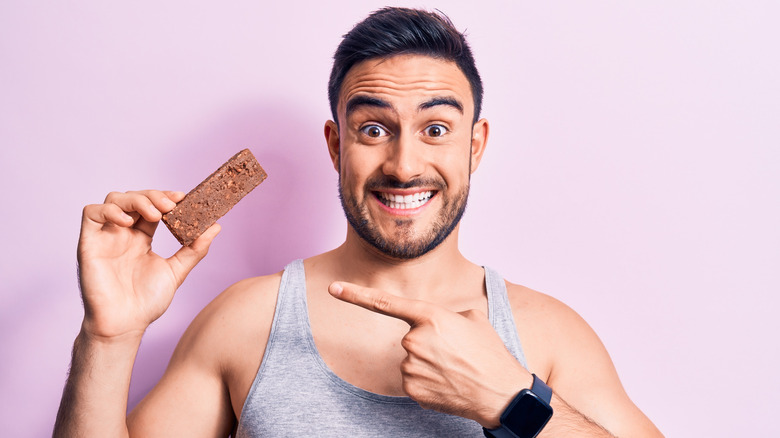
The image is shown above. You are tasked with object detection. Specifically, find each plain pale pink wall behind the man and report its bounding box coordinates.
[0,0,780,437]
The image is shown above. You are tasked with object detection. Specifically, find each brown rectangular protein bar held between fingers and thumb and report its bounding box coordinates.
[162,149,268,246]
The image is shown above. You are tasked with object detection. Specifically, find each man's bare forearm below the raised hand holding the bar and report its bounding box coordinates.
[53,330,141,437]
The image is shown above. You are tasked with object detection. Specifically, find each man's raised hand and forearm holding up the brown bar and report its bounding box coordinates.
[54,190,219,437]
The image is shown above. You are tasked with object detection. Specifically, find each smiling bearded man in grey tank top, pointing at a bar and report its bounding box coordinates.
[55,8,660,437]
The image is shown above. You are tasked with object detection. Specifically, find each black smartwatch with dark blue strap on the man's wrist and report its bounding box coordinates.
[482,374,552,438]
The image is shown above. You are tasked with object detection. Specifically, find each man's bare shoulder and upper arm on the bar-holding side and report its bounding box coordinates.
[127,273,281,438]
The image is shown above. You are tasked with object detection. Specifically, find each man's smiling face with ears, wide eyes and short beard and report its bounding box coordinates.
[326,55,487,259]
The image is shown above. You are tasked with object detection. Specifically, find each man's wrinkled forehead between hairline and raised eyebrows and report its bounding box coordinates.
[338,55,474,117]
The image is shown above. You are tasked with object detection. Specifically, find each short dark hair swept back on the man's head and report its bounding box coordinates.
[328,7,482,123]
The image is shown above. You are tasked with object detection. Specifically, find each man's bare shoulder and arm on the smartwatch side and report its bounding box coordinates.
[507,283,662,437]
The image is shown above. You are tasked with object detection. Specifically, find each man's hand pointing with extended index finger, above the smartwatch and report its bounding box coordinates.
[328,281,532,427]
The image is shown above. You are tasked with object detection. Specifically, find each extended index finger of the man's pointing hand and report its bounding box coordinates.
[328,281,440,327]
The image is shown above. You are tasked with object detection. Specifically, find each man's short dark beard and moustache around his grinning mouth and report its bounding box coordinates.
[339,176,469,260]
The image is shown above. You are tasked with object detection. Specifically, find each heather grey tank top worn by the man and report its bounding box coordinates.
[237,260,527,438]
